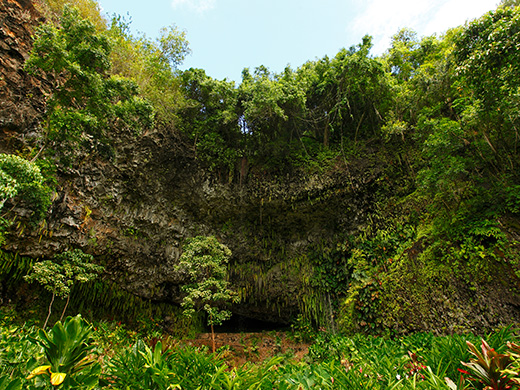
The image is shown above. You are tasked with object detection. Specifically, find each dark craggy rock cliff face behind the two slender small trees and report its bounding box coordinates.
[1,116,370,322]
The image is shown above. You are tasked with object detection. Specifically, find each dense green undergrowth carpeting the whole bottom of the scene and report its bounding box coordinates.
[0,308,520,390]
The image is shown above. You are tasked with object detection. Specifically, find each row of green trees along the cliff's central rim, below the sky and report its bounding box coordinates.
[175,36,389,175]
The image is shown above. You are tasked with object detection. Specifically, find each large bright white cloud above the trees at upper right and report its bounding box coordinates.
[348,0,499,54]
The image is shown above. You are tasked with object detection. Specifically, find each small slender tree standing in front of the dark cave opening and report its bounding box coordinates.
[177,236,238,352]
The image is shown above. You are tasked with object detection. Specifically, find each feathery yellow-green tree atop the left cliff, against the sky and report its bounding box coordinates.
[38,0,190,126]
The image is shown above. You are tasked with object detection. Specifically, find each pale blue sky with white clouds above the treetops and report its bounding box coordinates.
[98,0,499,82]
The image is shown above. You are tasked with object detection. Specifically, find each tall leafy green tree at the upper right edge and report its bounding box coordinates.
[454,7,520,180]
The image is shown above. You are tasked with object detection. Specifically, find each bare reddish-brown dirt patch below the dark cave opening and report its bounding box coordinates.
[182,331,309,366]
